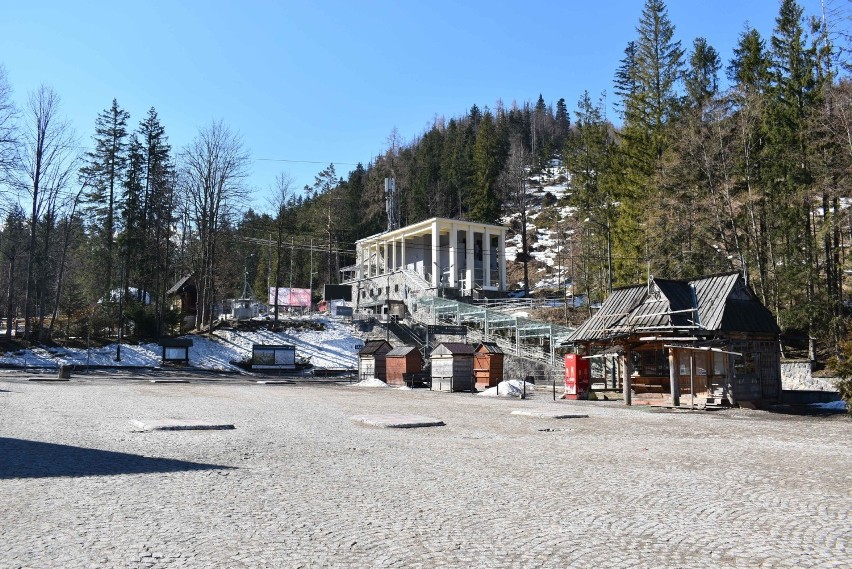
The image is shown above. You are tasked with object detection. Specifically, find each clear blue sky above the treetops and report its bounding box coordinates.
[0,0,820,210]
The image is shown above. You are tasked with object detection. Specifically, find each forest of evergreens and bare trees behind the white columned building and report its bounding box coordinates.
[0,0,852,358]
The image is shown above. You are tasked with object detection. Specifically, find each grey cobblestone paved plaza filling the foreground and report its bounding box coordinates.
[0,375,852,568]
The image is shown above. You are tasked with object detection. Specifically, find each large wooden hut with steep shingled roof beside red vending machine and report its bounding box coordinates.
[566,273,781,407]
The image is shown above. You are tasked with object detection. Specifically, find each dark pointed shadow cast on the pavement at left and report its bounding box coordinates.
[0,437,231,480]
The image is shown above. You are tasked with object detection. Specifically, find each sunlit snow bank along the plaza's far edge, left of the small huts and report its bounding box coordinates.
[0,317,363,371]
